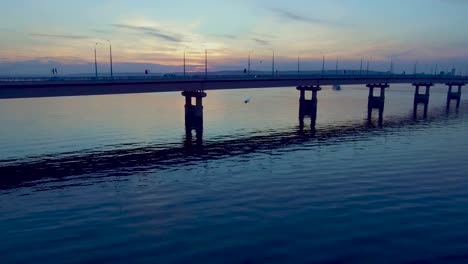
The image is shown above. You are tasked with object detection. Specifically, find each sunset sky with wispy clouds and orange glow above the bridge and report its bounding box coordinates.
[0,0,468,74]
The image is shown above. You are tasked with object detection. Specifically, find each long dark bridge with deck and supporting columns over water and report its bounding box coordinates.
[0,73,468,129]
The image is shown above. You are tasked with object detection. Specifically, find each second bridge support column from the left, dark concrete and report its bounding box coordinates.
[297,85,322,129]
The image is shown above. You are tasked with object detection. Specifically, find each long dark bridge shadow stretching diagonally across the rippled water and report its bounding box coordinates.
[0,104,468,190]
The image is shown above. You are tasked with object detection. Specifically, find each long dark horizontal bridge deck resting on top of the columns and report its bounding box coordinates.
[0,74,468,99]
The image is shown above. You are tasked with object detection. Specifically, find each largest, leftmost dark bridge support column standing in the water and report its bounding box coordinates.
[182,91,206,144]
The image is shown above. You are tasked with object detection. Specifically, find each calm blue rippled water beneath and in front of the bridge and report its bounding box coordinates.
[0,85,468,263]
